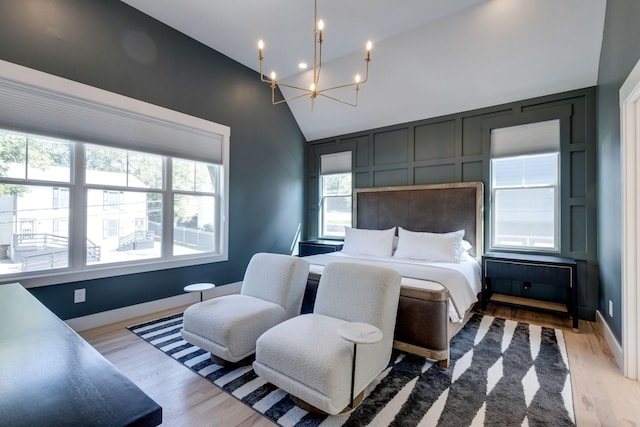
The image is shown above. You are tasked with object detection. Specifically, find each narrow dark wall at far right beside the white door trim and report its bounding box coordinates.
[597,0,640,342]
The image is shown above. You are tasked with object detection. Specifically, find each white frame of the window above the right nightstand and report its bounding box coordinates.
[489,119,561,253]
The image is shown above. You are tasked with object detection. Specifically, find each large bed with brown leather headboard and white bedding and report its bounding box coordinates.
[304,182,484,366]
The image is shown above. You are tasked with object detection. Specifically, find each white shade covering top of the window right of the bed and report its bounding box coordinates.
[491,119,560,159]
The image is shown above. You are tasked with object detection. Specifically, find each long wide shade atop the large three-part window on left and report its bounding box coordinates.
[0,61,230,164]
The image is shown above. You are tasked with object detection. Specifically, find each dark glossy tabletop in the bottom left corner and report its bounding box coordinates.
[0,283,162,426]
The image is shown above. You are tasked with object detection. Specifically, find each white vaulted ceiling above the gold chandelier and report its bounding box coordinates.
[123,0,606,141]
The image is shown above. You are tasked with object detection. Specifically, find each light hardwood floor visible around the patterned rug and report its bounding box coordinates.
[80,306,640,427]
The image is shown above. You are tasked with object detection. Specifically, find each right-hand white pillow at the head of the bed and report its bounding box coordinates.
[393,227,464,263]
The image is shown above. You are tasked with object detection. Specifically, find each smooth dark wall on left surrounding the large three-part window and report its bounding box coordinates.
[0,0,305,319]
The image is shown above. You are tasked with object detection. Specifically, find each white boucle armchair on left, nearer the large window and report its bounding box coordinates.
[181,253,309,362]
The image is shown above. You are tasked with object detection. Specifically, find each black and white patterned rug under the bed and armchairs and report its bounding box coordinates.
[129,314,575,427]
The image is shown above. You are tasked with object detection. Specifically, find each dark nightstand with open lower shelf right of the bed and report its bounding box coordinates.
[482,252,578,331]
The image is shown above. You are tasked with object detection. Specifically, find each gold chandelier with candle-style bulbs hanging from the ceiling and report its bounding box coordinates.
[258,0,372,108]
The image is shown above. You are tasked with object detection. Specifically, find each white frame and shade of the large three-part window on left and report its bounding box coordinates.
[0,60,231,288]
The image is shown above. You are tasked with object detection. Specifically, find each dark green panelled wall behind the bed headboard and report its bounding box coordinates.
[306,88,598,320]
